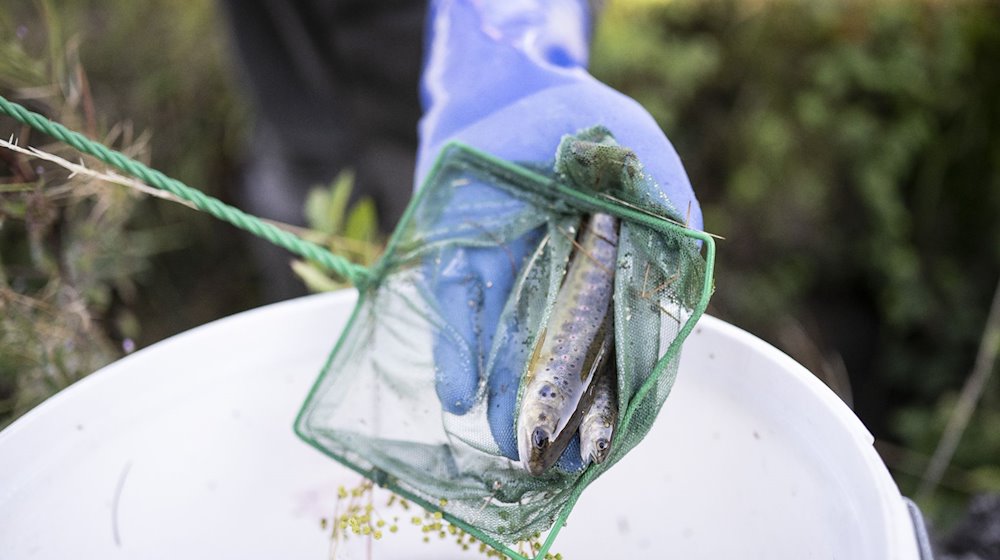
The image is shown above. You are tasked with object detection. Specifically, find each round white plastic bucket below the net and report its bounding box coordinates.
[0,291,919,560]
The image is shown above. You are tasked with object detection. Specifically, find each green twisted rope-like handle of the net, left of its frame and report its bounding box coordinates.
[0,95,372,288]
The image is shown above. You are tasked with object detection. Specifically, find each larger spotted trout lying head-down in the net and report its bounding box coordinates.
[517,214,618,476]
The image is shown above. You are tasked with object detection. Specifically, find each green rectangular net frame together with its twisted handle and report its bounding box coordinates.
[0,96,715,560]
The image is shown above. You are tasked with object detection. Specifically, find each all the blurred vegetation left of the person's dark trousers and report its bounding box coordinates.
[0,0,254,420]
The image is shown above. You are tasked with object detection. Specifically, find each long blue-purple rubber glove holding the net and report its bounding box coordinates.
[416,0,702,470]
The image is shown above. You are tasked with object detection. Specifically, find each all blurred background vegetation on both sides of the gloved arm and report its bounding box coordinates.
[0,0,1000,527]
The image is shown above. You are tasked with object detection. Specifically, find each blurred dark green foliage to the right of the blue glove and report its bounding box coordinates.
[592,0,1000,518]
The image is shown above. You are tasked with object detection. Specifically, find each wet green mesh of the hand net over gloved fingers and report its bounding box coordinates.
[296,127,711,544]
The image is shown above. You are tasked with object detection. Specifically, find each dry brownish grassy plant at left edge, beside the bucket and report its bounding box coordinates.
[0,0,154,420]
